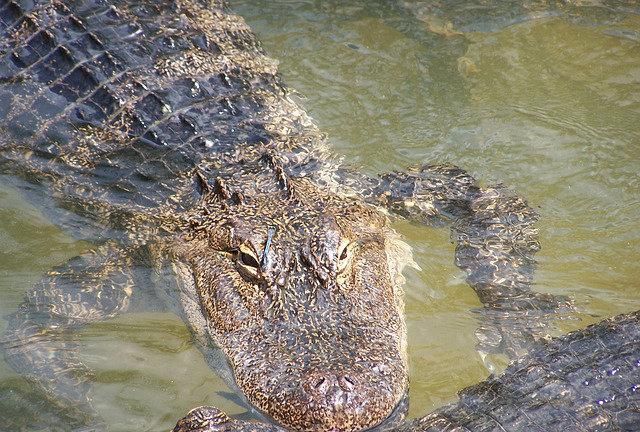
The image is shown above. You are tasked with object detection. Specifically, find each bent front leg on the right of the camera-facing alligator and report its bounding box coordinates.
[354,165,569,358]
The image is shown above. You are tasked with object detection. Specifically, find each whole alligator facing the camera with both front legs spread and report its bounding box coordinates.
[0,0,632,431]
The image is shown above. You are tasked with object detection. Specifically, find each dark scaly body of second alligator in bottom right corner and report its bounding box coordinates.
[408,311,640,432]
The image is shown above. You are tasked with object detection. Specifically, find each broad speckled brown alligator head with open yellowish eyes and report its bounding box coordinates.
[178,164,411,431]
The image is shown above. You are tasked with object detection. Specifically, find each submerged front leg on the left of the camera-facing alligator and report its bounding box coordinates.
[0,241,132,427]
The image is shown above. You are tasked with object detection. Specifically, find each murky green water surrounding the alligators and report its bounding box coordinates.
[0,0,640,431]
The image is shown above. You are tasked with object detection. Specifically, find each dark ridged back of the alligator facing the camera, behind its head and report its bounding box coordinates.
[0,0,317,221]
